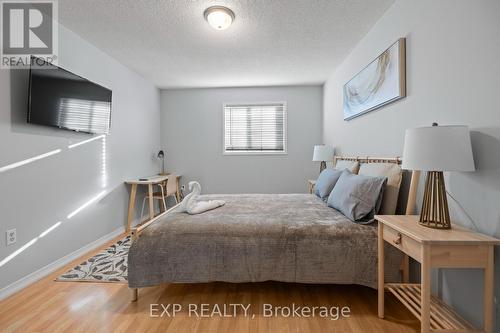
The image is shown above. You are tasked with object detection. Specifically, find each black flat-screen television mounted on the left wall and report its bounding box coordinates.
[28,57,112,134]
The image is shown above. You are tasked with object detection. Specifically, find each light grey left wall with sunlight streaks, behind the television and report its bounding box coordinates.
[0,26,160,289]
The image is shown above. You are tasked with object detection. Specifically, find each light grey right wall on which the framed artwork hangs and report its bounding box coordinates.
[323,0,500,326]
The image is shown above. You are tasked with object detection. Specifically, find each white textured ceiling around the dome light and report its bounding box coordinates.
[59,0,394,88]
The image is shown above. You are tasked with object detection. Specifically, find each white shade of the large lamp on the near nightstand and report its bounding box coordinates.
[402,126,475,171]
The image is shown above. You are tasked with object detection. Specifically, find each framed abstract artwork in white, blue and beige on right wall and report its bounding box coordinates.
[343,38,406,120]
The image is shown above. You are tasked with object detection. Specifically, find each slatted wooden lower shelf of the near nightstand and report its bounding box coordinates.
[385,283,476,332]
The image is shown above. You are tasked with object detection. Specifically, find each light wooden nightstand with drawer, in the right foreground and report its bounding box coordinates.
[375,215,500,333]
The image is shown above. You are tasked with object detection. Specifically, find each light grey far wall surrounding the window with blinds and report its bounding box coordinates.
[161,86,322,193]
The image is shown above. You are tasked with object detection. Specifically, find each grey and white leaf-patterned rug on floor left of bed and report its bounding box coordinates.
[56,236,132,283]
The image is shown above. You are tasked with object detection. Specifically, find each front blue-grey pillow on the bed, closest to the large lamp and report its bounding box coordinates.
[328,170,387,223]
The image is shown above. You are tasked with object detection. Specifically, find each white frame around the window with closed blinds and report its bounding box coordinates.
[222,101,288,156]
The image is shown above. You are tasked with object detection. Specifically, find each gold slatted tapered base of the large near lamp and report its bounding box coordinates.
[419,171,451,229]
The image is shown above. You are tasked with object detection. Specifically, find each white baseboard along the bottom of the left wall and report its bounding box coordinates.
[0,227,125,301]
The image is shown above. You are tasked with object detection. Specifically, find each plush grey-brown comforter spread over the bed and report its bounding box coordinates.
[128,194,401,288]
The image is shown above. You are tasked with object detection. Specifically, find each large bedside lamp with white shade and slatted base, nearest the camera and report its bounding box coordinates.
[402,123,475,229]
